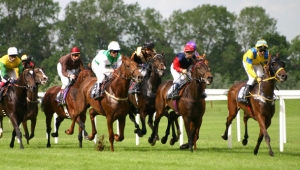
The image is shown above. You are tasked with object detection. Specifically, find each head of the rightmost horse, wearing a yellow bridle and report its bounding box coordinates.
[265,56,287,82]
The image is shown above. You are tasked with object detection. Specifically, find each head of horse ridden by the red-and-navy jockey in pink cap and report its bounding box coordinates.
[189,60,213,85]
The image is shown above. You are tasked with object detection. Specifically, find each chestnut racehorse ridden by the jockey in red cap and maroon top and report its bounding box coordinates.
[41,69,93,147]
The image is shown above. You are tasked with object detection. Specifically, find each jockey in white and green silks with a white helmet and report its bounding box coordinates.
[92,41,122,100]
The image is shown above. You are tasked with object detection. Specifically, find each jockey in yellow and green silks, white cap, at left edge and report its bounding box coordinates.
[0,47,23,88]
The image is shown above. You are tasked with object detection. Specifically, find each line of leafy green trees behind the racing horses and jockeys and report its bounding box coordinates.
[0,0,300,91]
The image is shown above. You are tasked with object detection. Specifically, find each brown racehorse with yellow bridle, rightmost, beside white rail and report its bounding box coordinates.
[222,56,287,156]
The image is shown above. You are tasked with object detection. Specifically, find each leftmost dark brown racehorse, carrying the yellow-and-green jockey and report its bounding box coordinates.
[0,68,37,149]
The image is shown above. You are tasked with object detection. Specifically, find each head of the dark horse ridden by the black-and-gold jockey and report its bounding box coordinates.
[149,54,166,77]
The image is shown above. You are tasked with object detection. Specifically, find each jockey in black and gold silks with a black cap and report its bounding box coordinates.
[128,41,156,93]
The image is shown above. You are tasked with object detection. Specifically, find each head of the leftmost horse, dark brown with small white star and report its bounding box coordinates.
[18,68,37,92]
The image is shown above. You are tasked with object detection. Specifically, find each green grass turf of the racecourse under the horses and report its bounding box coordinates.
[0,100,300,170]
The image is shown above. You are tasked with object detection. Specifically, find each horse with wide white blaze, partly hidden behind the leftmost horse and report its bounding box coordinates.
[22,67,48,144]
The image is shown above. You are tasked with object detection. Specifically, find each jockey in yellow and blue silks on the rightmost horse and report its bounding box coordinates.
[239,39,269,103]
